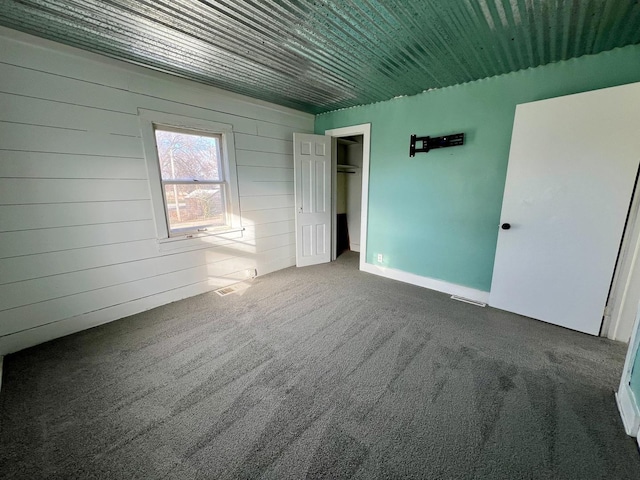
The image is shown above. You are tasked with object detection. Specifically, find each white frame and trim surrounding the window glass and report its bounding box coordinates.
[138,109,243,250]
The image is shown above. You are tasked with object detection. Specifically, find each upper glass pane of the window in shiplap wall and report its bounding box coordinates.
[156,129,222,180]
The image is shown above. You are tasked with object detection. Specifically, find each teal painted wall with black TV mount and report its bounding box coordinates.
[315,45,640,291]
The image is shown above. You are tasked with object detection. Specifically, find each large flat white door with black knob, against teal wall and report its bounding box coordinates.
[489,84,640,335]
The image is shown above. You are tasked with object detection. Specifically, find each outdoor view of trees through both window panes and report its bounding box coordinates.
[155,127,226,233]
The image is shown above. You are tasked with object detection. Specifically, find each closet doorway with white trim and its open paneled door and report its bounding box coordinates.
[293,123,371,270]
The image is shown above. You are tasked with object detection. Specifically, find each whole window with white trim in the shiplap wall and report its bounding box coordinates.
[140,111,241,246]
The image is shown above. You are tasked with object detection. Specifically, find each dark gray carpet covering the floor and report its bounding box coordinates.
[0,254,640,479]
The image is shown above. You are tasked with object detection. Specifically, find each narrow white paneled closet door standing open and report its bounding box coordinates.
[293,133,332,267]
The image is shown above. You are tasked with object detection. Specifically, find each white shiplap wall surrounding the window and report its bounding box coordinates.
[0,28,313,355]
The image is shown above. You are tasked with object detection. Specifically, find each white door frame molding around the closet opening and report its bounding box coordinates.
[324,123,371,270]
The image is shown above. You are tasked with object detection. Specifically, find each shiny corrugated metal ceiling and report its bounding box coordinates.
[0,0,640,113]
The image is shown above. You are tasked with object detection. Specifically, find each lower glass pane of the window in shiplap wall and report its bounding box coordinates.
[164,184,226,231]
